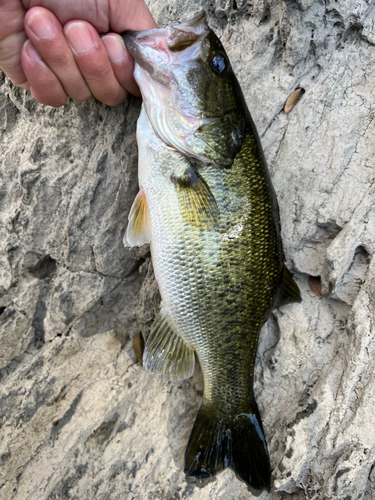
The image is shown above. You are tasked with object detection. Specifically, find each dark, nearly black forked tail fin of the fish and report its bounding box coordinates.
[185,403,271,491]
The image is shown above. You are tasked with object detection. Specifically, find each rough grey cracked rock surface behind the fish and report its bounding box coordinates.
[0,0,375,500]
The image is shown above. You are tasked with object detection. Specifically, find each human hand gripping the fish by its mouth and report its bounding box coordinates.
[0,0,157,107]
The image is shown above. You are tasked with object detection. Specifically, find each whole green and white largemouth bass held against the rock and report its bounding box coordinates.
[123,11,301,491]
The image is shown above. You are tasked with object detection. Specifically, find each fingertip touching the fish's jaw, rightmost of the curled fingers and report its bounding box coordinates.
[102,33,141,97]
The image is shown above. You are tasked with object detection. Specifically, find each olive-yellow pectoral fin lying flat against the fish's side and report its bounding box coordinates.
[171,166,220,229]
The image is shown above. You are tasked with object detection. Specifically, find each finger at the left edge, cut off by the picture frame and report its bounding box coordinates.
[0,0,28,88]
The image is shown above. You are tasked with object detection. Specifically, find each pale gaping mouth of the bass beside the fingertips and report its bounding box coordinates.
[121,10,209,76]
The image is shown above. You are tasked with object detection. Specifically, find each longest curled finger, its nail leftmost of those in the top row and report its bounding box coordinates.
[25,7,91,101]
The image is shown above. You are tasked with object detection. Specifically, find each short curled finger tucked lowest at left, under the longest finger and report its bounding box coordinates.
[21,40,68,108]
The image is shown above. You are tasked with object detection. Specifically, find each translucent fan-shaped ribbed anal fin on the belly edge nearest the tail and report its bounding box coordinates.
[143,303,195,380]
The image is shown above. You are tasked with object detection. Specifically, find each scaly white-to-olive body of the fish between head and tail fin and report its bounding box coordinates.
[142,118,282,413]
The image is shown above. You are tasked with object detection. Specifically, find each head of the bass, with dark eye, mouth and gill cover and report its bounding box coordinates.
[123,12,247,166]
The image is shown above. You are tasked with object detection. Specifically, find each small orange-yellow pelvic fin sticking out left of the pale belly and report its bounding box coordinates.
[124,189,151,247]
